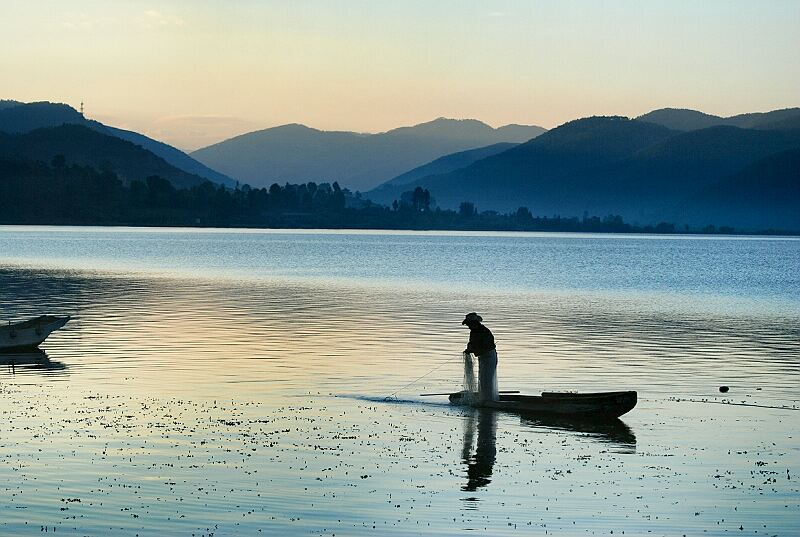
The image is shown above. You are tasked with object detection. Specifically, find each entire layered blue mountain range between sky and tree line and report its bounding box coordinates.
[0,101,800,231]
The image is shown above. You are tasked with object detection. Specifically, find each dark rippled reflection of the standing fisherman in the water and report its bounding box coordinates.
[461,409,497,491]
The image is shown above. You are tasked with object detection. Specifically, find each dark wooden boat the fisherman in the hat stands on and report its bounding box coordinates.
[450,391,637,419]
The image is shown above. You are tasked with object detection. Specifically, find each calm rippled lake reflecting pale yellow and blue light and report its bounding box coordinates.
[0,226,800,536]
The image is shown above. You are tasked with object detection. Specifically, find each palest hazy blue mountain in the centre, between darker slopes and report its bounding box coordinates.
[192,118,545,191]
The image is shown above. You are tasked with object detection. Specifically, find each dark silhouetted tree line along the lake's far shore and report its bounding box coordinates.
[0,156,734,233]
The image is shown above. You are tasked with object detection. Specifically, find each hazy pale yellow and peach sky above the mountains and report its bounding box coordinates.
[0,0,800,148]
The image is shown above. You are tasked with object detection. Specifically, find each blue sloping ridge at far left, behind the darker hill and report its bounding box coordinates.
[0,100,235,186]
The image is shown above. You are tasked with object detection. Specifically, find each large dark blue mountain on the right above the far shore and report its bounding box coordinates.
[365,114,800,229]
